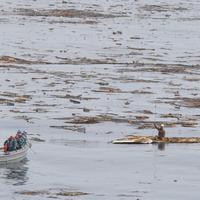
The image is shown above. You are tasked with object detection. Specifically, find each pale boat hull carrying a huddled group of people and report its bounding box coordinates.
[0,141,31,165]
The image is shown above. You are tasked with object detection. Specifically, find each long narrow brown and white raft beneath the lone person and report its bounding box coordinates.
[112,136,200,144]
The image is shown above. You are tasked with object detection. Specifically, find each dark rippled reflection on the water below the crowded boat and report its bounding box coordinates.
[0,158,28,185]
